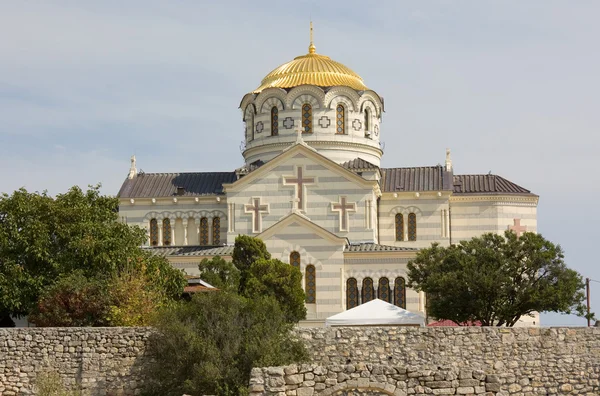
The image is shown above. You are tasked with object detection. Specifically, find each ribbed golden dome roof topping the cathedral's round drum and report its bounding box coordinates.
[254,40,367,93]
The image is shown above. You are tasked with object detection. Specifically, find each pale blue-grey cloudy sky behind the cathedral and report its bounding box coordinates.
[0,0,600,325]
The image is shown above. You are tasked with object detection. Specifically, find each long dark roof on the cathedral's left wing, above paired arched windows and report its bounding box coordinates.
[119,172,237,198]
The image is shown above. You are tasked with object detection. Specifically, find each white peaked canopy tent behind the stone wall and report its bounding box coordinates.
[325,299,425,326]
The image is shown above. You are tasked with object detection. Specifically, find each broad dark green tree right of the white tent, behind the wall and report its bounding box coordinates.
[408,231,585,326]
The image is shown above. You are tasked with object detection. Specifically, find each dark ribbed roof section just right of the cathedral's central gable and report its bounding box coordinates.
[381,165,444,192]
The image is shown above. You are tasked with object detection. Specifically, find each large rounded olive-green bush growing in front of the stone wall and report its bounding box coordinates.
[145,291,307,396]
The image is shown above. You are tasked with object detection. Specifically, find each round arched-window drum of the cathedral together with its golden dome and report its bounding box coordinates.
[240,35,383,166]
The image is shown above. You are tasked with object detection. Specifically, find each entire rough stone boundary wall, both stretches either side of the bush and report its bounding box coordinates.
[0,327,600,396]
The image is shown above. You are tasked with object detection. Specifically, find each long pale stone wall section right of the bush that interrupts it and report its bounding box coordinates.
[251,327,600,396]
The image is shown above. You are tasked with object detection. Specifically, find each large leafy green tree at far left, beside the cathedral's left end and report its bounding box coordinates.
[0,186,185,321]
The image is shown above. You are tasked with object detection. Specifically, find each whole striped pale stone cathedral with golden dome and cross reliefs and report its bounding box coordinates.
[118,27,539,326]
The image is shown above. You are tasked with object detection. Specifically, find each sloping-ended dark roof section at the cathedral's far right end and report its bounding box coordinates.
[454,174,535,195]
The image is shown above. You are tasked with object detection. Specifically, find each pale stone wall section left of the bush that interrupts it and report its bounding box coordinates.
[0,328,151,396]
